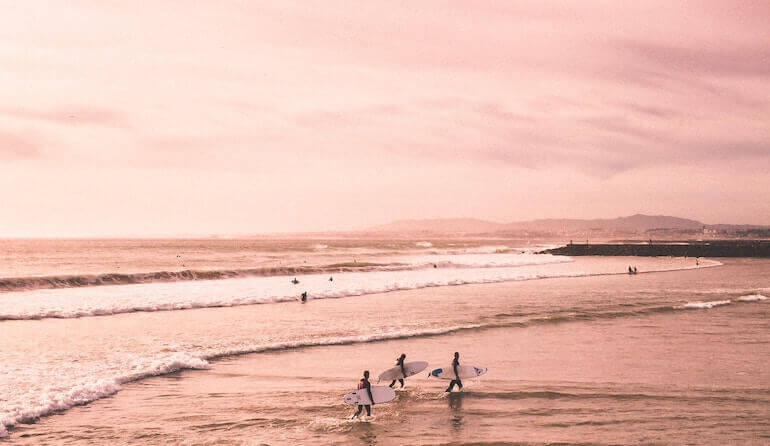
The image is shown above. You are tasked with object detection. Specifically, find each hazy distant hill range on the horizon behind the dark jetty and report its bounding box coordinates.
[368,214,705,234]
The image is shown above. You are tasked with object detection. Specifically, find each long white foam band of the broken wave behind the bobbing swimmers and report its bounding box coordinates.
[0,257,718,321]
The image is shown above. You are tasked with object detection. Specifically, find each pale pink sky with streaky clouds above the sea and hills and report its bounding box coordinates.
[0,0,770,237]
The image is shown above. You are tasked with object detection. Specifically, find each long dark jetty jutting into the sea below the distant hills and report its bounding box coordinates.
[539,240,770,258]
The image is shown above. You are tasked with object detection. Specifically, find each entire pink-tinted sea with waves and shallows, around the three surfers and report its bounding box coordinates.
[0,237,770,445]
